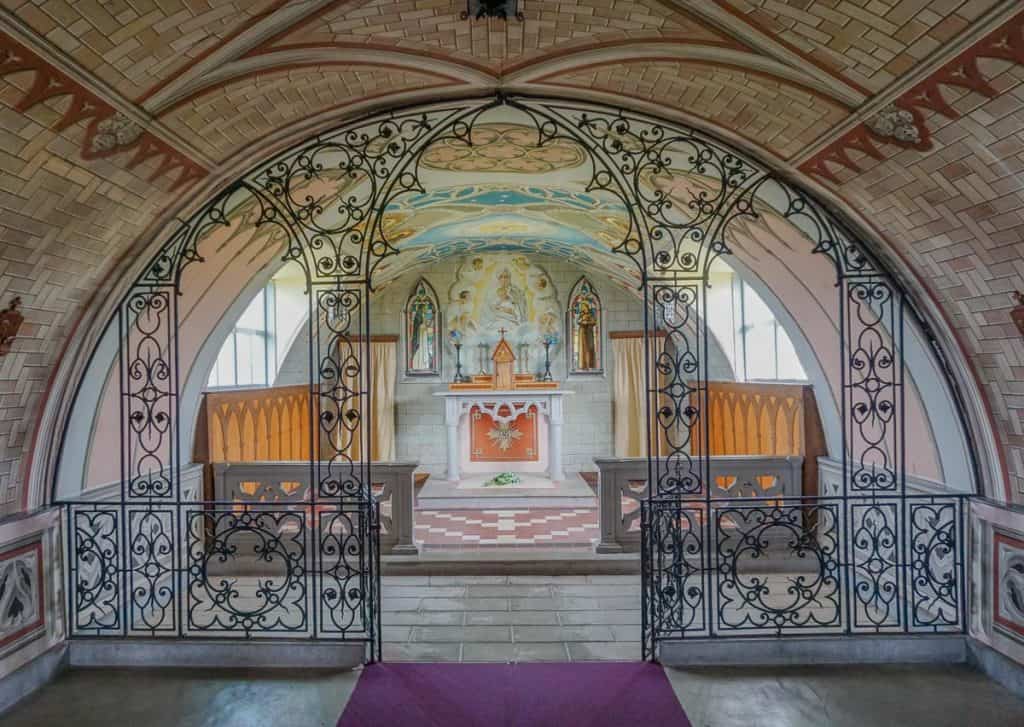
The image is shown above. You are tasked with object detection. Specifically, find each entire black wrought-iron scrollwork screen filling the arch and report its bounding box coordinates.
[54,96,964,658]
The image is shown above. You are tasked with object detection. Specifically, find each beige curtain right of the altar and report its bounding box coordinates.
[611,337,647,457]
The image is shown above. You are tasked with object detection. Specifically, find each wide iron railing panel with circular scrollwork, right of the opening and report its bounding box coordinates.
[713,502,843,636]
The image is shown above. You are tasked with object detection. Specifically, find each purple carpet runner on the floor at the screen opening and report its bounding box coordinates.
[338,662,690,727]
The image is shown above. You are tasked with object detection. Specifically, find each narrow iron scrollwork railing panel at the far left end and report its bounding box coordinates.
[68,505,125,636]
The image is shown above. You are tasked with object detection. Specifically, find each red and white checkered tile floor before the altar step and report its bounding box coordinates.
[415,508,597,547]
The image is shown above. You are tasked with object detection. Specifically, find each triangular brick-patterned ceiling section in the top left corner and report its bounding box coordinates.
[3,0,276,98]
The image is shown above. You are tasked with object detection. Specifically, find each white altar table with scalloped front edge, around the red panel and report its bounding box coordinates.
[434,389,572,482]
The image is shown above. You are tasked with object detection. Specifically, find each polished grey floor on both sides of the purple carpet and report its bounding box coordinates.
[0,667,1024,727]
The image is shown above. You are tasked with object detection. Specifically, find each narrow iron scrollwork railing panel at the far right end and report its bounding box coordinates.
[906,498,965,631]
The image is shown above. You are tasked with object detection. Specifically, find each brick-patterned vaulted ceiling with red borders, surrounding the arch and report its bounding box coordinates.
[0,0,1024,511]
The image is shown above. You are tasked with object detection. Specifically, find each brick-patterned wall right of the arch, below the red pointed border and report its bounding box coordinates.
[819,60,1024,500]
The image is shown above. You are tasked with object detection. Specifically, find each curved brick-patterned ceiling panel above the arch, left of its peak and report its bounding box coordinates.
[163,66,451,160]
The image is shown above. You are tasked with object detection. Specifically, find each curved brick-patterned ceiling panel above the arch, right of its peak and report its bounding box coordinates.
[547,62,847,159]
